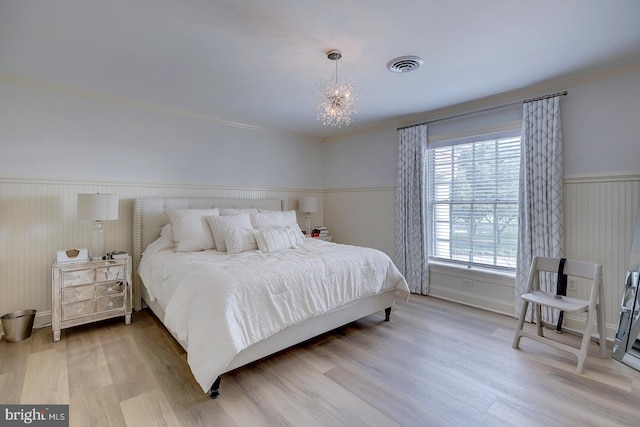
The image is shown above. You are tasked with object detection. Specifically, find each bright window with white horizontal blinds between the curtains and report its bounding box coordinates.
[428,136,520,269]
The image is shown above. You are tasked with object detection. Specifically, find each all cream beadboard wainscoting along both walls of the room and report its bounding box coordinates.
[0,175,640,337]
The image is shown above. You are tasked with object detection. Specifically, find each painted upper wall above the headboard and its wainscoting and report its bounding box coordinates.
[0,77,323,189]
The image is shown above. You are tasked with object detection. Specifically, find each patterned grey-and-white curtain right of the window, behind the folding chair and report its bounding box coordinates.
[515,96,564,323]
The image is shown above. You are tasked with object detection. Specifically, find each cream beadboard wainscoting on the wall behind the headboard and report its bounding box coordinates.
[0,178,323,334]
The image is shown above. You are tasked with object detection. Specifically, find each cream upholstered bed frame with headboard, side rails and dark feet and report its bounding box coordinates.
[133,197,395,399]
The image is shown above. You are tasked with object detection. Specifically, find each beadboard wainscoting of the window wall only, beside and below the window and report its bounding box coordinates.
[324,175,640,338]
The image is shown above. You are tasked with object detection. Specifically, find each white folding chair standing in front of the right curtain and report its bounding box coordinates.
[513,257,607,374]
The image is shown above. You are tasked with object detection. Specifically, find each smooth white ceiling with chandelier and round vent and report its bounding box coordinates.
[0,0,640,138]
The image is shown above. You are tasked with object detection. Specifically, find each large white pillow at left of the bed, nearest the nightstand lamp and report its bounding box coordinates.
[165,208,219,252]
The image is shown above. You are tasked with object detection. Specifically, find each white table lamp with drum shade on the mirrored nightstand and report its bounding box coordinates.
[78,193,118,260]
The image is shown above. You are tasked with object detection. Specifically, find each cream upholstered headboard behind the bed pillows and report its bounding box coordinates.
[132,197,282,310]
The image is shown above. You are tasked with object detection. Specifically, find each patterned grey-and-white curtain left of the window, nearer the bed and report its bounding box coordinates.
[396,125,429,295]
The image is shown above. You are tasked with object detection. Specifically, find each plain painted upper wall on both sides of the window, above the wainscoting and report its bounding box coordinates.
[324,70,640,189]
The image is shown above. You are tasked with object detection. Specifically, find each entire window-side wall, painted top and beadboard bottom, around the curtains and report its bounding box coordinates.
[324,67,640,333]
